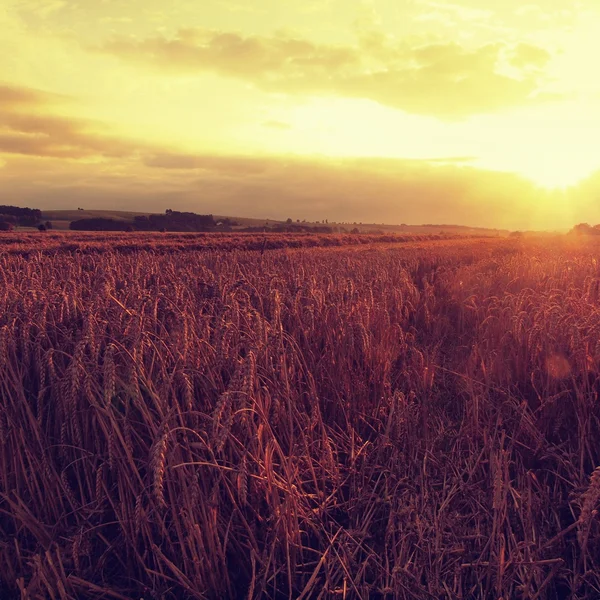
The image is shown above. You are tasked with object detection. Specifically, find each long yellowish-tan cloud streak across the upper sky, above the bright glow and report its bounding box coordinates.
[96,28,548,119]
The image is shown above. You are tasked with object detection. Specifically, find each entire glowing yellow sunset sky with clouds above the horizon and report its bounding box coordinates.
[0,0,600,229]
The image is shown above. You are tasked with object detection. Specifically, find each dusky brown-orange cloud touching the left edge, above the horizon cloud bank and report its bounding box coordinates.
[0,85,144,159]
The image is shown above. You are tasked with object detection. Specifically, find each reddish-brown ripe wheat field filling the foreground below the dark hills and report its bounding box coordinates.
[0,234,600,600]
